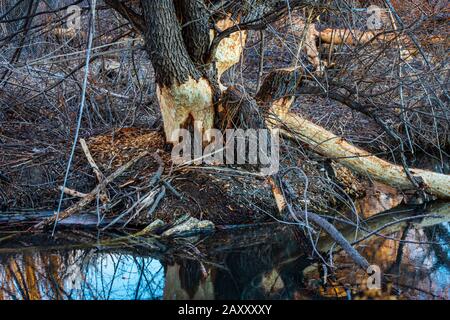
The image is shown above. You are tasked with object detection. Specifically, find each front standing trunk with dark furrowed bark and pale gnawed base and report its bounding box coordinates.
[142,0,214,142]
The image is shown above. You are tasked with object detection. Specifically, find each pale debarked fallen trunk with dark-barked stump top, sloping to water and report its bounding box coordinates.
[256,68,450,199]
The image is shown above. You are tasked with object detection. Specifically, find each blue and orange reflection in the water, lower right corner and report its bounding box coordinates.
[330,222,450,299]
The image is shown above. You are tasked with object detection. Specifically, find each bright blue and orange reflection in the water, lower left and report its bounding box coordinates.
[0,249,164,300]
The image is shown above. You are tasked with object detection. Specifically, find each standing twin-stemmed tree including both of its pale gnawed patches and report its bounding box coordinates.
[142,0,250,143]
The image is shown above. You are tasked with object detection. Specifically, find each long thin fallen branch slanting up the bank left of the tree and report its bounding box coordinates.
[32,151,148,229]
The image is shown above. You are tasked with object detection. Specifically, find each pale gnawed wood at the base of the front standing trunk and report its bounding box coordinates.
[156,78,214,143]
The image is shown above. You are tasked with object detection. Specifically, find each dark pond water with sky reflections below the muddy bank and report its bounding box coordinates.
[0,204,450,300]
